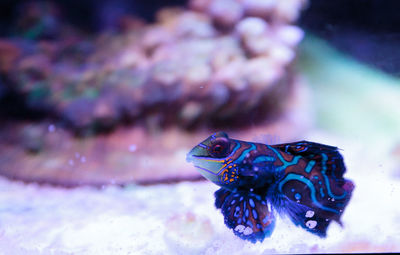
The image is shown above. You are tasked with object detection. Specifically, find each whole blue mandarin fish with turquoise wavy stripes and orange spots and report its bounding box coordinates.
[187,132,354,243]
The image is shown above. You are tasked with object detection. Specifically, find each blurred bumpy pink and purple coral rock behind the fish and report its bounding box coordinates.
[1,0,303,134]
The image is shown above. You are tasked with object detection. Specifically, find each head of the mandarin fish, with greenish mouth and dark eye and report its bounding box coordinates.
[186,132,235,186]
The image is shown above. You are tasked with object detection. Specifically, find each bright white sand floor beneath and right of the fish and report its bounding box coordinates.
[0,133,400,255]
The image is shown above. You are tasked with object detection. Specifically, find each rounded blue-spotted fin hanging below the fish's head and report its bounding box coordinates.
[215,188,275,243]
